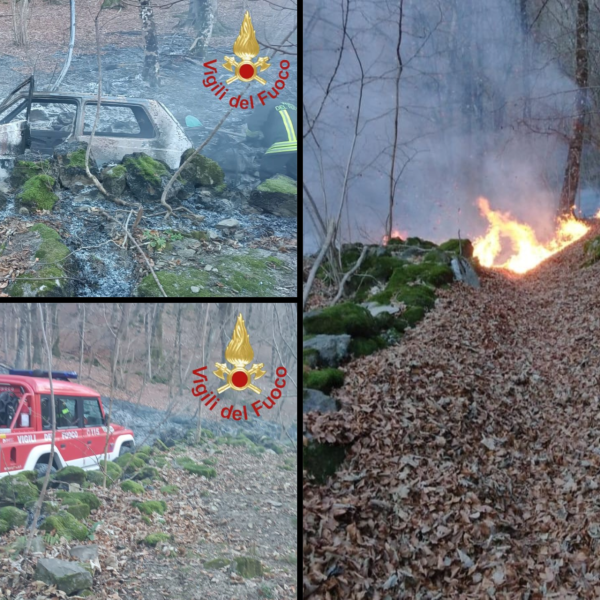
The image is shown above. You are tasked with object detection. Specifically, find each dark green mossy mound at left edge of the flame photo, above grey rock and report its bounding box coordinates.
[304,302,378,337]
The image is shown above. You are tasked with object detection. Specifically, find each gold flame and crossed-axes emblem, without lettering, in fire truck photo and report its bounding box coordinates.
[213,314,266,394]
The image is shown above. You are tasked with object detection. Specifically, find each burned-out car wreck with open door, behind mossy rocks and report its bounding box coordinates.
[0,76,192,168]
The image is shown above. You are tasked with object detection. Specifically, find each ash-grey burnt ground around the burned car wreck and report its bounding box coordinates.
[0,2,297,297]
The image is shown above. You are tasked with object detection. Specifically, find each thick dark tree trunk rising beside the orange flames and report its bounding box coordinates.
[558,0,589,215]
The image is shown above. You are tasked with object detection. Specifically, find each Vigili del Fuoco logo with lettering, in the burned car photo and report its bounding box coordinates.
[202,11,290,110]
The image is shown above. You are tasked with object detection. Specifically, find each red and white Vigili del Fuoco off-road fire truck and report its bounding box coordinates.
[0,369,135,478]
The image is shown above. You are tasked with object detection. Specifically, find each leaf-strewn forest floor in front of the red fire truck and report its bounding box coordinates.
[0,443,297,600]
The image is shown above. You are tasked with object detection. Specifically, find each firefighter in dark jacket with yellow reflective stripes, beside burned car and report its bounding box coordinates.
[246,102,297,181]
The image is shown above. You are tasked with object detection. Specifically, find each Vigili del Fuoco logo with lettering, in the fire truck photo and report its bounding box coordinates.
[192,314,287,421]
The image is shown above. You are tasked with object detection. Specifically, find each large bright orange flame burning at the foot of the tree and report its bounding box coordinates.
[473,198,590,273]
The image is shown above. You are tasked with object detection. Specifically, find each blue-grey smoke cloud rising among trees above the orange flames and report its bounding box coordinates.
[304,0,576,252]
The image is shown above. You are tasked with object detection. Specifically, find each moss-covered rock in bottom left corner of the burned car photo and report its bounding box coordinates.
[7,223,72,298]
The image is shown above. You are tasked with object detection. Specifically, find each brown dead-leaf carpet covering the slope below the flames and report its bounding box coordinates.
[303,226,600,600]
